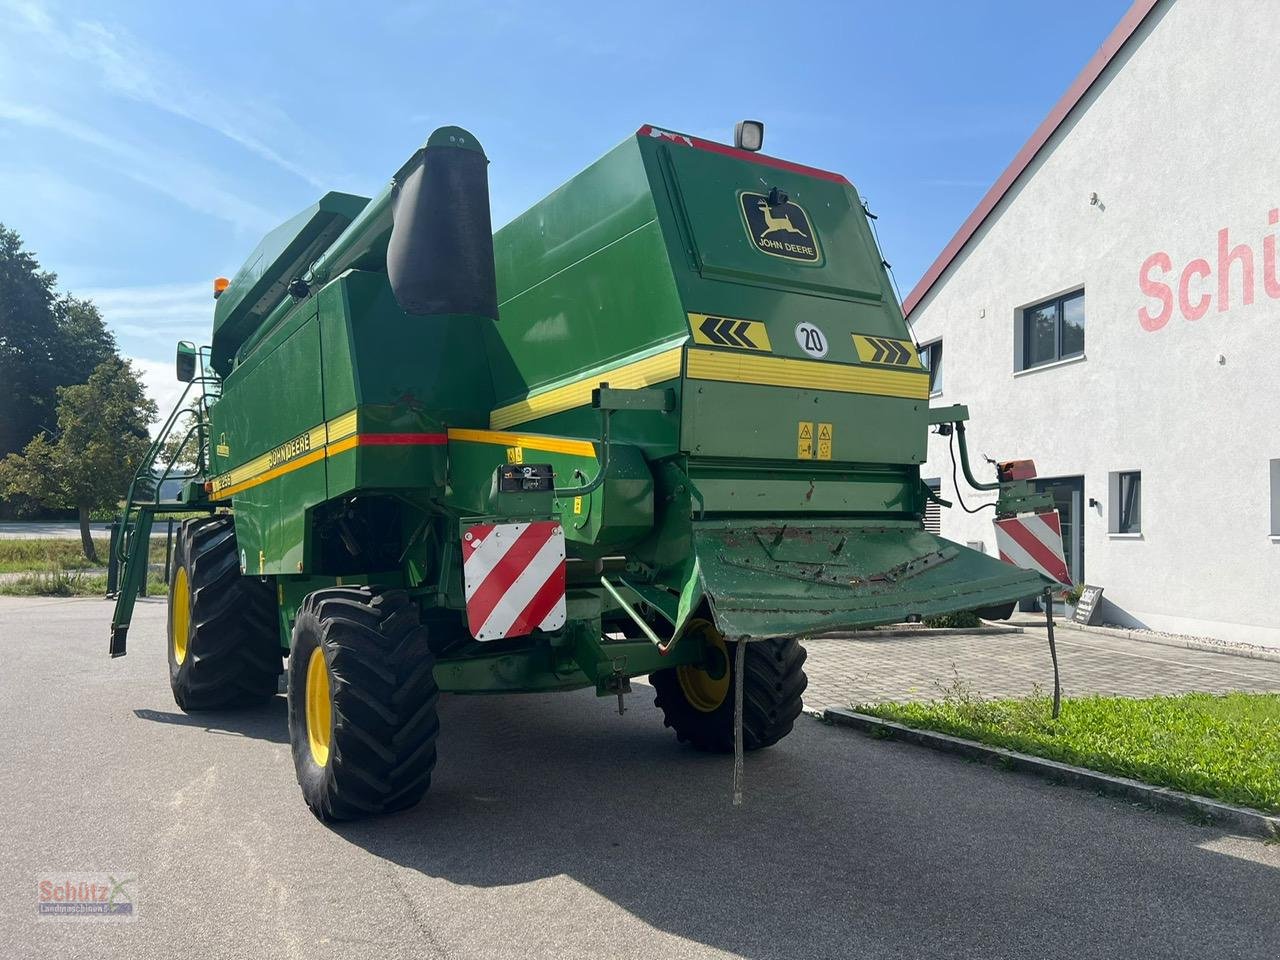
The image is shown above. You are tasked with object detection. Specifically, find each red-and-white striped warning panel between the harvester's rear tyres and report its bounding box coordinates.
[462,520,564,640]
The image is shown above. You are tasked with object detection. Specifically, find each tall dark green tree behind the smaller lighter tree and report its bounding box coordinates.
[0,224,115,457]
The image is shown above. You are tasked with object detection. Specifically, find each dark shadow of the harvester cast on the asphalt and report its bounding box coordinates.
[317,687,1280,959]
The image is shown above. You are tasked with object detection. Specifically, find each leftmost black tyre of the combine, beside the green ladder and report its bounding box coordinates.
[168,516,283,710]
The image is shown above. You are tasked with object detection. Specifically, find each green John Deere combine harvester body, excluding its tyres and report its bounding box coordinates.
[112,127,1044,694]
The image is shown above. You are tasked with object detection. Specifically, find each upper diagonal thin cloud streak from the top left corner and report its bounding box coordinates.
[0,0,335,188]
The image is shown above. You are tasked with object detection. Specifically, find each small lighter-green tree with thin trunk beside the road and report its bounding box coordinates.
[0,356,156,563]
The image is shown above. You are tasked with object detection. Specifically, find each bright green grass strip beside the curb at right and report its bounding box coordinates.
[854,694,1280,813]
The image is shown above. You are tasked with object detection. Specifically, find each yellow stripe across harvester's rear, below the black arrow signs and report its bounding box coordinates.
[687,349,929,399]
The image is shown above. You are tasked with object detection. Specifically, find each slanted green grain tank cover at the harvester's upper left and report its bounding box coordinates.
[212,192,369,376]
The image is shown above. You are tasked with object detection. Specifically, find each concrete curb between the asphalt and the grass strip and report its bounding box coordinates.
[822,707,1280,840]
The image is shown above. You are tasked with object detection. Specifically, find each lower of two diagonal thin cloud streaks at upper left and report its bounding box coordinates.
[0,99,284,233]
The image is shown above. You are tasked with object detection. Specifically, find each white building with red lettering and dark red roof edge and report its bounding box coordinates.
[904,0,1280,646]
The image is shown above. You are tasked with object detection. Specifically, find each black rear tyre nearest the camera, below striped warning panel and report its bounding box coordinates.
[288,586,440,822]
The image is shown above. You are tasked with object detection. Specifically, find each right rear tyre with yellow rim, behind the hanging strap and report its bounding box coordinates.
[649,620,809,753]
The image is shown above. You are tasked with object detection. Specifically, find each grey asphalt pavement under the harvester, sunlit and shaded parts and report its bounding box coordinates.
[0,598,1280,960]
